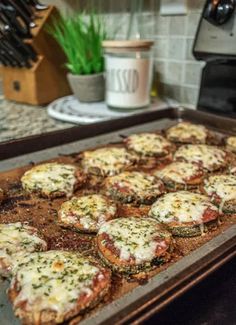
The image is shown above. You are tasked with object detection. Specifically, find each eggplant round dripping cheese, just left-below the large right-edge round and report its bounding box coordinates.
[149,191,219,237]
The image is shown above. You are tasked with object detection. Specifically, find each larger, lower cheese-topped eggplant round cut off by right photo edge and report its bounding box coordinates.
[202,175,236,213]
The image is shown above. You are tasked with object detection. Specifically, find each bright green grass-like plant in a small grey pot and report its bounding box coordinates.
[47,13,106,102]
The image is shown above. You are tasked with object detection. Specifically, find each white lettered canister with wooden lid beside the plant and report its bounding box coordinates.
[103,40,153,109]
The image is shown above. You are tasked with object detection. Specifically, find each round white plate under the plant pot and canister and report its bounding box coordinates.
[47,96,168,124]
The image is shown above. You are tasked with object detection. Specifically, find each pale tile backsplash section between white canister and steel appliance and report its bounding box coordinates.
[150,1,204,107]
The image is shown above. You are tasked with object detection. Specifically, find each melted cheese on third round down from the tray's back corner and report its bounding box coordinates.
[154,161,201,184]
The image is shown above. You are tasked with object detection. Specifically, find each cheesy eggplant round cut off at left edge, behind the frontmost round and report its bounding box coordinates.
[0,222,47,277]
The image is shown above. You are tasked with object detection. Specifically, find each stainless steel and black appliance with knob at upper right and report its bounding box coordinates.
[193,0,236,117]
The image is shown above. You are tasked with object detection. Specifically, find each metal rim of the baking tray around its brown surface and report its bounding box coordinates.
[0,108,236,325]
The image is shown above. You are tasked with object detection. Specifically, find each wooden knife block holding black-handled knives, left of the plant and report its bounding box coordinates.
[2,6,71,105]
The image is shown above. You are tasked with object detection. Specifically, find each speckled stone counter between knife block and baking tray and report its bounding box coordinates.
[0,96,74,142]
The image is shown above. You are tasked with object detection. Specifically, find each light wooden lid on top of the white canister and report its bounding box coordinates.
[102,39,154,52]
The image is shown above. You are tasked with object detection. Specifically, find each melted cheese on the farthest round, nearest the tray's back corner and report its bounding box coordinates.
[167,122,207,143]
